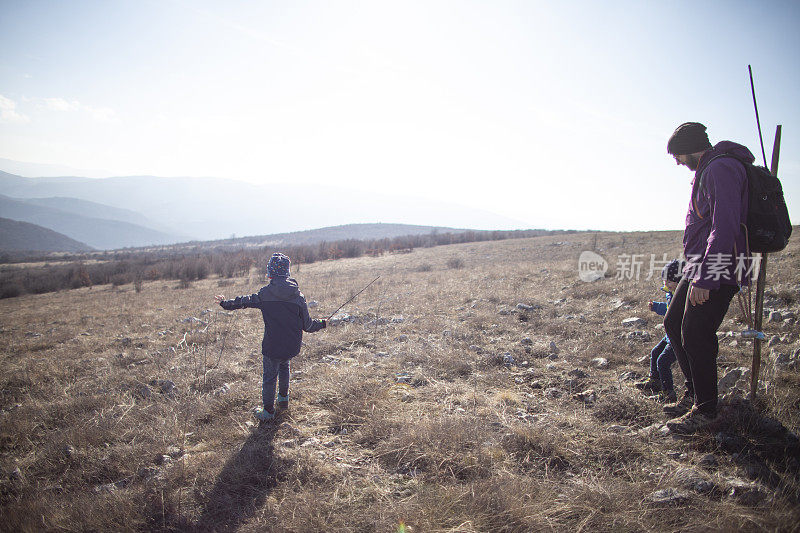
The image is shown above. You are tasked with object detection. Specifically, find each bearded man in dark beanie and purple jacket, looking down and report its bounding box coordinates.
[664,122,754,435]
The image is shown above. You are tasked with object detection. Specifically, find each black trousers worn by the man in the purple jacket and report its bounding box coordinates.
[664,278,739,416]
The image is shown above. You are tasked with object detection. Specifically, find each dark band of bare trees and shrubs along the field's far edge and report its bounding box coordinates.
[0,230,575,298]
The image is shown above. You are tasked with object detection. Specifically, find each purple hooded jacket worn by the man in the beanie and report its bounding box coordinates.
[683,141,755,290]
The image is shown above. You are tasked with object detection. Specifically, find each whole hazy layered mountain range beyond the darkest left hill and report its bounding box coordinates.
[0,166,523,249]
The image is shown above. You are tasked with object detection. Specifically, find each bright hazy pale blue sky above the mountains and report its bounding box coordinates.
[0,0,800,229]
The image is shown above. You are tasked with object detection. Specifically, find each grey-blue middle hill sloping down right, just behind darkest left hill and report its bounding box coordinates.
[0,193,186,250]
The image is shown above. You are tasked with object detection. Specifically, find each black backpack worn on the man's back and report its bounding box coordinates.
[692,154,792,253]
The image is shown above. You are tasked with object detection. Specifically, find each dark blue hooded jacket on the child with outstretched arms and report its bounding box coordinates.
[220,277,327,361]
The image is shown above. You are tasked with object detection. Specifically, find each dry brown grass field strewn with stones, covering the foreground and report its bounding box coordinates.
[0,232,800,532]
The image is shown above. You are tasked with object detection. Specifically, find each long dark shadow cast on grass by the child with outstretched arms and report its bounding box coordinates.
[194,426,279,531]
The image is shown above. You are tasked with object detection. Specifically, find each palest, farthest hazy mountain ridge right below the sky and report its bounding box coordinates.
[0,173,525,242]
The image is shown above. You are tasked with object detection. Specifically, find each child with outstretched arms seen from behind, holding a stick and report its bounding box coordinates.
[215,253,327,421]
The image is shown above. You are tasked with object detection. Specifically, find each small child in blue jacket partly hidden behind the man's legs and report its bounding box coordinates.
[636,259,685,402]
